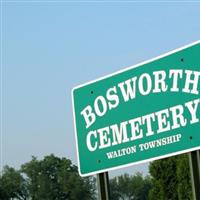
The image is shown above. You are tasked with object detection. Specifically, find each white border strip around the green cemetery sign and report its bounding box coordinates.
[71,40,200,177]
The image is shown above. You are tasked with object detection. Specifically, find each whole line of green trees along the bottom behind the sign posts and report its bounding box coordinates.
[0,154,192,200]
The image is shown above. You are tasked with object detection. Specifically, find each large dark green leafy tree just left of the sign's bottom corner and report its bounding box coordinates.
[21,154,94,200]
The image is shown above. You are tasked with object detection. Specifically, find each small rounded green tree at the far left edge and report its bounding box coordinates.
[0,166,28,200]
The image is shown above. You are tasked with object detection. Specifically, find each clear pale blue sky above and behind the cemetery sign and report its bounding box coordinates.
[0,0,200,176]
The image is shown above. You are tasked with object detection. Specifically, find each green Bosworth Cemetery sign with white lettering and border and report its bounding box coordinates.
[72,41,200,176]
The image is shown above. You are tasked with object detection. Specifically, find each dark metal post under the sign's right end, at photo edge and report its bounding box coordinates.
[189,150,200,200]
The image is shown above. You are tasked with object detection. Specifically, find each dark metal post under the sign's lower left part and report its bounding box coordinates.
[97,172,110,200]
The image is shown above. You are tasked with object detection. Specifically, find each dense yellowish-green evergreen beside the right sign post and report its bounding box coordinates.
[149,155,192,200]
